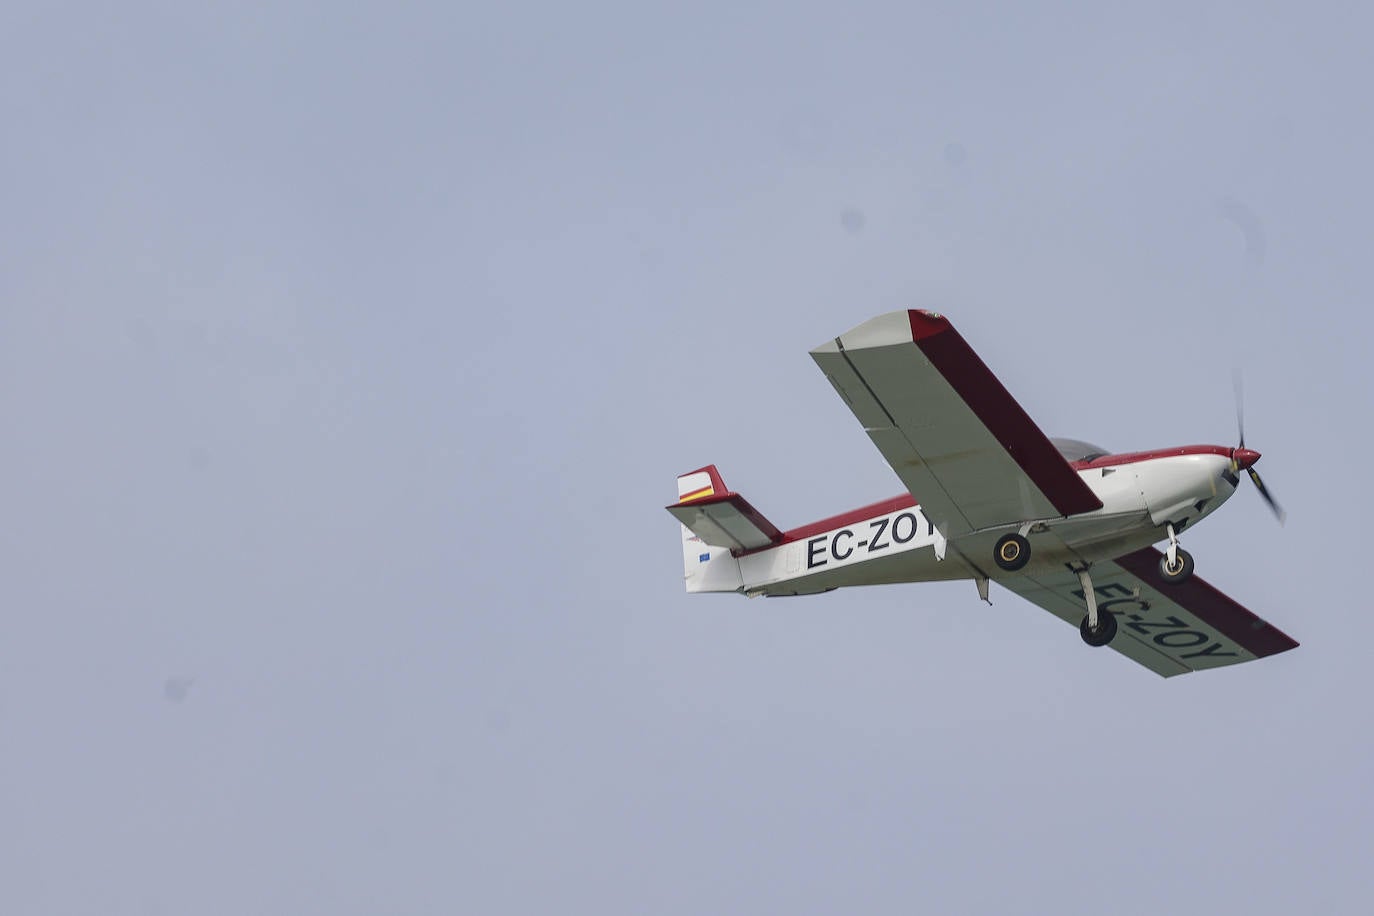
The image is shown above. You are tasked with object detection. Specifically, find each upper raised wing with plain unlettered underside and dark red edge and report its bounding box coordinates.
[811,310,1102,537]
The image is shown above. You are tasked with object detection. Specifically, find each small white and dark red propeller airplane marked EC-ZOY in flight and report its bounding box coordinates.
[666,309,1298,677]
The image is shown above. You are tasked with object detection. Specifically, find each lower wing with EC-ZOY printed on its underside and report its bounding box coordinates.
[998,547,1297,677]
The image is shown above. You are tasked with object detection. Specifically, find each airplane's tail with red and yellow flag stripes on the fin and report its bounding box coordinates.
[668,464,782,592]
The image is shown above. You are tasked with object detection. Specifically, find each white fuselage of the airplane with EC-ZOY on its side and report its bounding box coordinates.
[738,446,1235,595]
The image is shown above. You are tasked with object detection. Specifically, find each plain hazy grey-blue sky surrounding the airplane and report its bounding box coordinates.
[0,3,1374,916]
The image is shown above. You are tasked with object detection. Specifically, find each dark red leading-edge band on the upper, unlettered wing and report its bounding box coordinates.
[910,310,1102,515]
